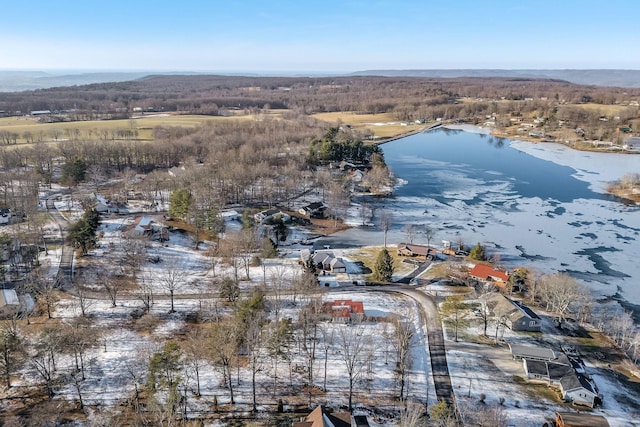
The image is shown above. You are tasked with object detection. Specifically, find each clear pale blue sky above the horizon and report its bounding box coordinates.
[0,0,640,72]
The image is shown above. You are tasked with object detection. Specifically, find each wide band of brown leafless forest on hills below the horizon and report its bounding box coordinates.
[0,76,640,123]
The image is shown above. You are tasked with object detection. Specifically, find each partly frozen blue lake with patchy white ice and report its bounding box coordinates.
[323,125,640,307]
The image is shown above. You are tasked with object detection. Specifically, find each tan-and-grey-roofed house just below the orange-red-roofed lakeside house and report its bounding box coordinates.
[480,292,542,332]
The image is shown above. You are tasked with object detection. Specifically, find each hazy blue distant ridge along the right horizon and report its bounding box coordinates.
[350,69,640,88]
